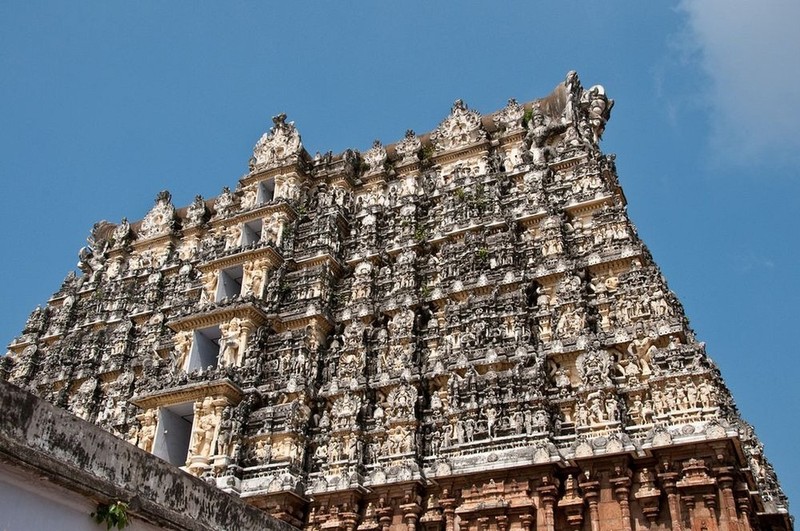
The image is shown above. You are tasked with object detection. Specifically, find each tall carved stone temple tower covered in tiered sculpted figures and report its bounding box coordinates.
[0,72,792,531]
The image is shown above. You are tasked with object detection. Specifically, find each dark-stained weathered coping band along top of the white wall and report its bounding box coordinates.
[0,382,294,531]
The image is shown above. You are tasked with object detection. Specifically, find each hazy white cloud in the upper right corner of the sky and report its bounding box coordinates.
[680,0,800,165]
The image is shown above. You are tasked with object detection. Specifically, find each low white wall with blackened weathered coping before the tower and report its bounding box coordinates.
[0,382,294,531]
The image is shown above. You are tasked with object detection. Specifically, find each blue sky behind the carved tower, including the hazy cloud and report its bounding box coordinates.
[0,0,800,508]
